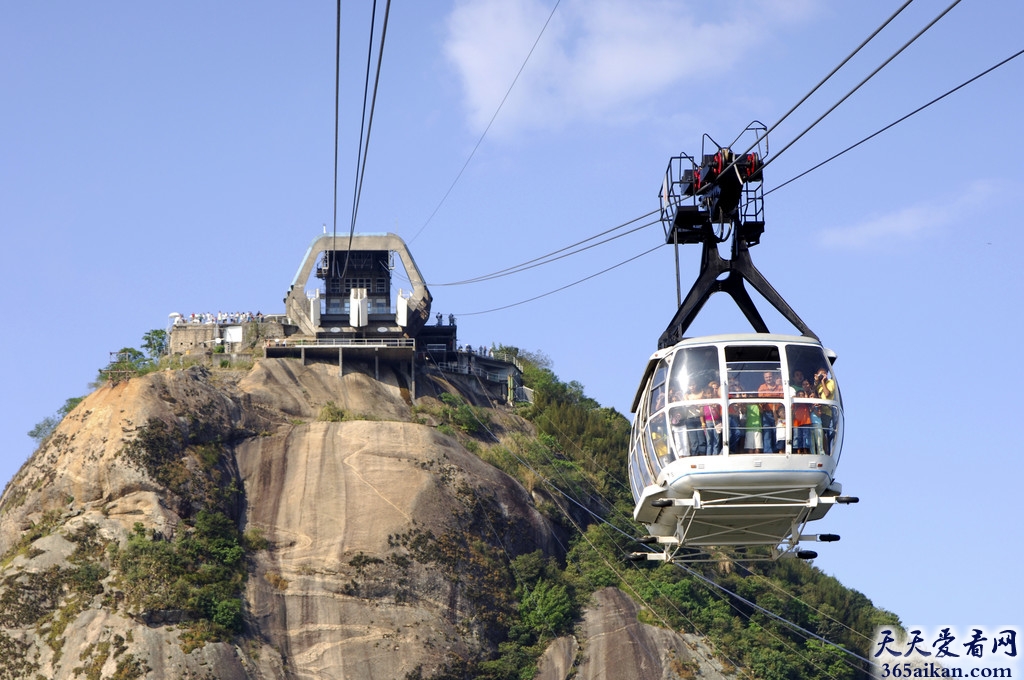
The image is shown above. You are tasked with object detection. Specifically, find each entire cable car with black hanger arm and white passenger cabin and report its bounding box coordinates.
[629,123,858,561]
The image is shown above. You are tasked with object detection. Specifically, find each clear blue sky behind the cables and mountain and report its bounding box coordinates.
[0,0,1024,651]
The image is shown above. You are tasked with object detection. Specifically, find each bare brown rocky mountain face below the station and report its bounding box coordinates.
[0,359,735,680]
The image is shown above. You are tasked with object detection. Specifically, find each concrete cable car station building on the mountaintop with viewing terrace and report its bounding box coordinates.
[170,233,525,398]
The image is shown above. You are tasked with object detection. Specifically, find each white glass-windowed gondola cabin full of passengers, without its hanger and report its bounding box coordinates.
[629,334,846,550]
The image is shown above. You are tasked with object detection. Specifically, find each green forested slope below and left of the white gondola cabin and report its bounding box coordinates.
[417,347,898,680]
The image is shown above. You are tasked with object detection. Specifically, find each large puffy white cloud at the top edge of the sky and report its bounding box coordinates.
[444,0,807,133]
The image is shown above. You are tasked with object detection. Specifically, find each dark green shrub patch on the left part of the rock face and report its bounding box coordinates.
[109,409,251,649]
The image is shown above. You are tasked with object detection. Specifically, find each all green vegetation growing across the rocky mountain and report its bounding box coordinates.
[0,332,897,680]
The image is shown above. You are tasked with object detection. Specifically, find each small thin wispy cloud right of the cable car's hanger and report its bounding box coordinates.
[818,180,1005,249]
